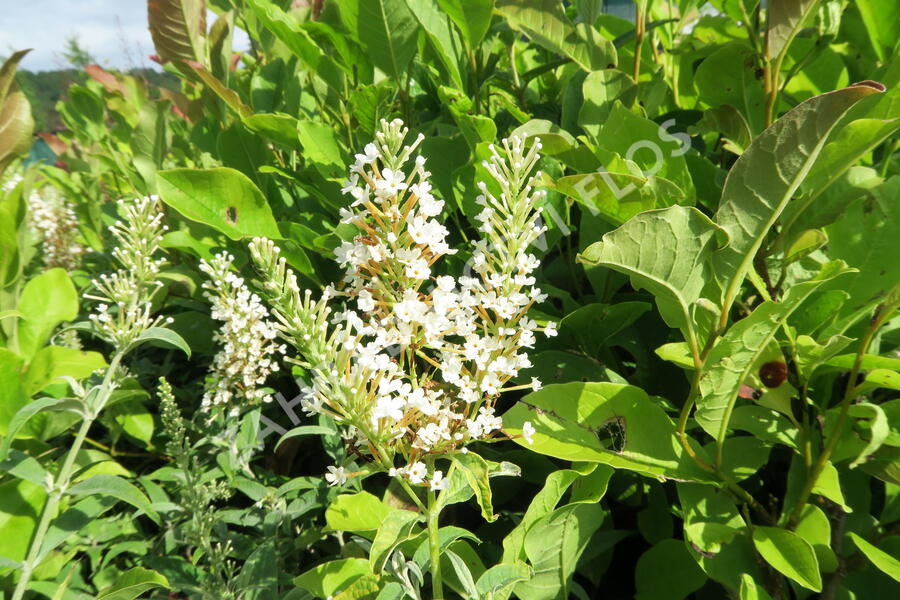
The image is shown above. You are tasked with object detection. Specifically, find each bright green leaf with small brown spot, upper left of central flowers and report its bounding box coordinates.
[158,167,281,240]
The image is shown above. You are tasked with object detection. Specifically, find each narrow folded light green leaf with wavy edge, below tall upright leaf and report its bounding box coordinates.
[695,261,851,449]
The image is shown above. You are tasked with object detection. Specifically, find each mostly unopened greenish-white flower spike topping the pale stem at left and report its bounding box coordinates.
[85,196,171,345]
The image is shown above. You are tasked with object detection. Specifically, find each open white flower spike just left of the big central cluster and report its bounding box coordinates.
[200,253,286,414]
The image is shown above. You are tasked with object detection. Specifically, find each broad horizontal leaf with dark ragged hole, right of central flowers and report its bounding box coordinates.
[503,382,708,481]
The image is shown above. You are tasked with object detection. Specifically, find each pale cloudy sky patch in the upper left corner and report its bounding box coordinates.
[0,0,248,71]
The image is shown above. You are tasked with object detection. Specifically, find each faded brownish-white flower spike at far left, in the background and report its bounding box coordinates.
[28,185,87,271]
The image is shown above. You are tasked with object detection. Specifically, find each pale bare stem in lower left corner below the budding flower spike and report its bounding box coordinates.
[12,352,123,600]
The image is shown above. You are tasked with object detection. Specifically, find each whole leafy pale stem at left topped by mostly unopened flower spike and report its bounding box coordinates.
[0,197,190,600]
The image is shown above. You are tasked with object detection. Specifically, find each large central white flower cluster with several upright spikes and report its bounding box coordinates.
[251,121,556,489]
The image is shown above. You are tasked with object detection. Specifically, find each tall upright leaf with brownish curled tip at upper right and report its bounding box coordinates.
[716,84,883,307]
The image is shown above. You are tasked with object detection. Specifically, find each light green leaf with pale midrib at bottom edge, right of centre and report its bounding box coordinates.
[515,504,606,600]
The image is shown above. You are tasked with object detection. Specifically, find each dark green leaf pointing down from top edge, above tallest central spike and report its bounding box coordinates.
[350,0,419,81]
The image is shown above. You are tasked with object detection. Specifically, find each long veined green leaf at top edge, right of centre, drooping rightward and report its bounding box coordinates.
[496,0,618,71]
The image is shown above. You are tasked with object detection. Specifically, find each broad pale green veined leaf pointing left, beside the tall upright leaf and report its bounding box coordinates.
[579,206,726,354]
